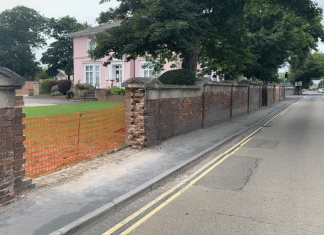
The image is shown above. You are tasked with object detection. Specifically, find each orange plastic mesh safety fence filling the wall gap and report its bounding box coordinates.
[23,104,125,178]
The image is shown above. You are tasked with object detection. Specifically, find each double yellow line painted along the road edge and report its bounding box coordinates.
[102,104,295,235]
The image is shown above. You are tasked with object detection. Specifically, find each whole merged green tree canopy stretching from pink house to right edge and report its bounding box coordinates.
[91,0,324,81]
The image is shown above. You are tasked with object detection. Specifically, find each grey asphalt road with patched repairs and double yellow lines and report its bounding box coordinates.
[79,95,324,235]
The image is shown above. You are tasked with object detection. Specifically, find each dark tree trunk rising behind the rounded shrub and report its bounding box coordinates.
[182,36,201,74]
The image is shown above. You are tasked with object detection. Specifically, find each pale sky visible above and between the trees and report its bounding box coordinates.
[0,0,324,72]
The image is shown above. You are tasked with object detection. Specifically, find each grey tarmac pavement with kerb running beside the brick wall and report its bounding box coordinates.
[0,96,302,235]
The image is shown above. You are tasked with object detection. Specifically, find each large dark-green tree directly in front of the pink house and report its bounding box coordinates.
[91,0,321,76]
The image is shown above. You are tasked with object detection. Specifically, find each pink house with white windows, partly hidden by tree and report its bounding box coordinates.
[68,21,177,88]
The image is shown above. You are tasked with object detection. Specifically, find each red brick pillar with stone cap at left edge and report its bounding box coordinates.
[0,67,33,204]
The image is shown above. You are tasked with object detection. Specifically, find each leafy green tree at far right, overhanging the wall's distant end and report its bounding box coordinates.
[243,2,324,82]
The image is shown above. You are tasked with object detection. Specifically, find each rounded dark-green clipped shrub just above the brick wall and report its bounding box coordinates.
[159,69,196,85]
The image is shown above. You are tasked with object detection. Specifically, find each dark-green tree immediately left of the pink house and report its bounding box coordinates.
[40,16,89,77]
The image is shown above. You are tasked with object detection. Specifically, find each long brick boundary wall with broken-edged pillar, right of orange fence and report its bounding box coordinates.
[123,78,280,149]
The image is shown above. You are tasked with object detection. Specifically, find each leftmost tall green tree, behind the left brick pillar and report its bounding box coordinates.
[0,6,47,80]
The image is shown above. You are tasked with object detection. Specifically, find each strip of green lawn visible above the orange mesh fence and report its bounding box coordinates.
[23,101,121,118]
